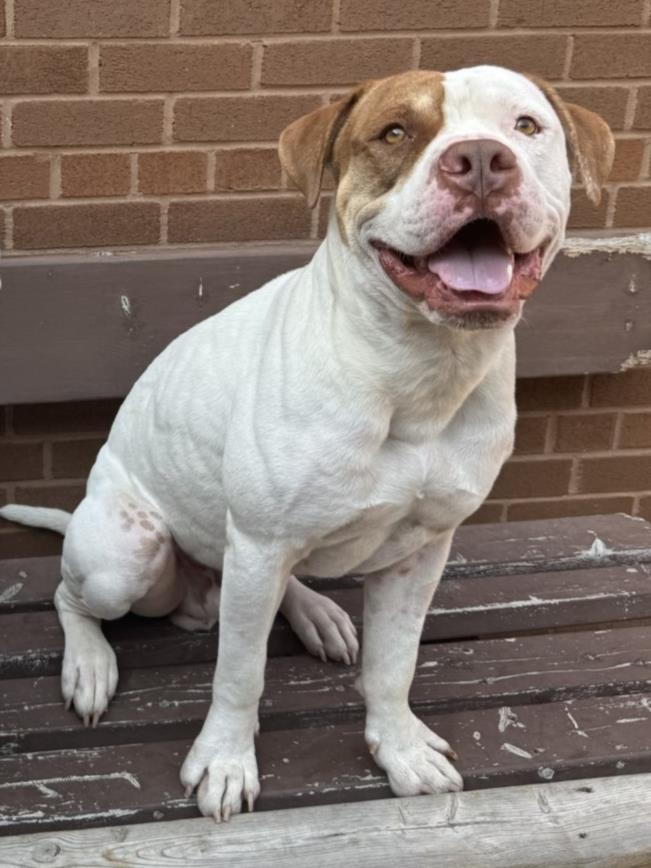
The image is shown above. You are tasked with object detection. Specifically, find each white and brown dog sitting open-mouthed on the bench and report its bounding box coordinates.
[0,66,613,820]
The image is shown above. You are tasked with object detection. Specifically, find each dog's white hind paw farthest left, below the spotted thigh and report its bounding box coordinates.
[61,641,118,727]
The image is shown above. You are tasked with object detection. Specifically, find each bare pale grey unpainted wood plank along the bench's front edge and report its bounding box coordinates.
[0,774,651,868]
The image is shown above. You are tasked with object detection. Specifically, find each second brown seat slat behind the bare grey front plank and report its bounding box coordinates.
[0,627,651,754]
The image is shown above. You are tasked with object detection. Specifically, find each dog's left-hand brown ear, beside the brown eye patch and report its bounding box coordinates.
[278,88,361,208]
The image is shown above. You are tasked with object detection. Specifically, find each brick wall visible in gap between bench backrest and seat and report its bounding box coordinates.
[0,370,651,559]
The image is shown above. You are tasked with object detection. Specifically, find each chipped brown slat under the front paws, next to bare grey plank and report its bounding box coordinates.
[0,695,651,834]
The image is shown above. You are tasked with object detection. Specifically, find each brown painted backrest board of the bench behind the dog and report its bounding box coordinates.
[0,242,651,404]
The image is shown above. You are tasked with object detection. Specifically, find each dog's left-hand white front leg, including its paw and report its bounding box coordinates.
[181,521,291,822]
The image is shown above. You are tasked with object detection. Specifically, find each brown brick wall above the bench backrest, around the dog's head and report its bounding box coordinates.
[0,0,651,254]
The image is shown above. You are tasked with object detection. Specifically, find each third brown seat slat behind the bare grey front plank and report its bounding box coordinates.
[0,564,651,678]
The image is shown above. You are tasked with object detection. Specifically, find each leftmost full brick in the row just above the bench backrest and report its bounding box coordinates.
[14,202,160,250]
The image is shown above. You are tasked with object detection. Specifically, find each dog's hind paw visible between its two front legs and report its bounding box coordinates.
[281,579,359,666]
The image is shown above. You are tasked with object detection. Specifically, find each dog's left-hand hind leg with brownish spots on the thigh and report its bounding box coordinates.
[55,488,183,725]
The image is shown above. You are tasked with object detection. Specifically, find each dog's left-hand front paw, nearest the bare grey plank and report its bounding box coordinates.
[181,739,260,823]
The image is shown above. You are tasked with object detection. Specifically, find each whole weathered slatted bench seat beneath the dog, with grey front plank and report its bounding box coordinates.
[0,515,651,866]
